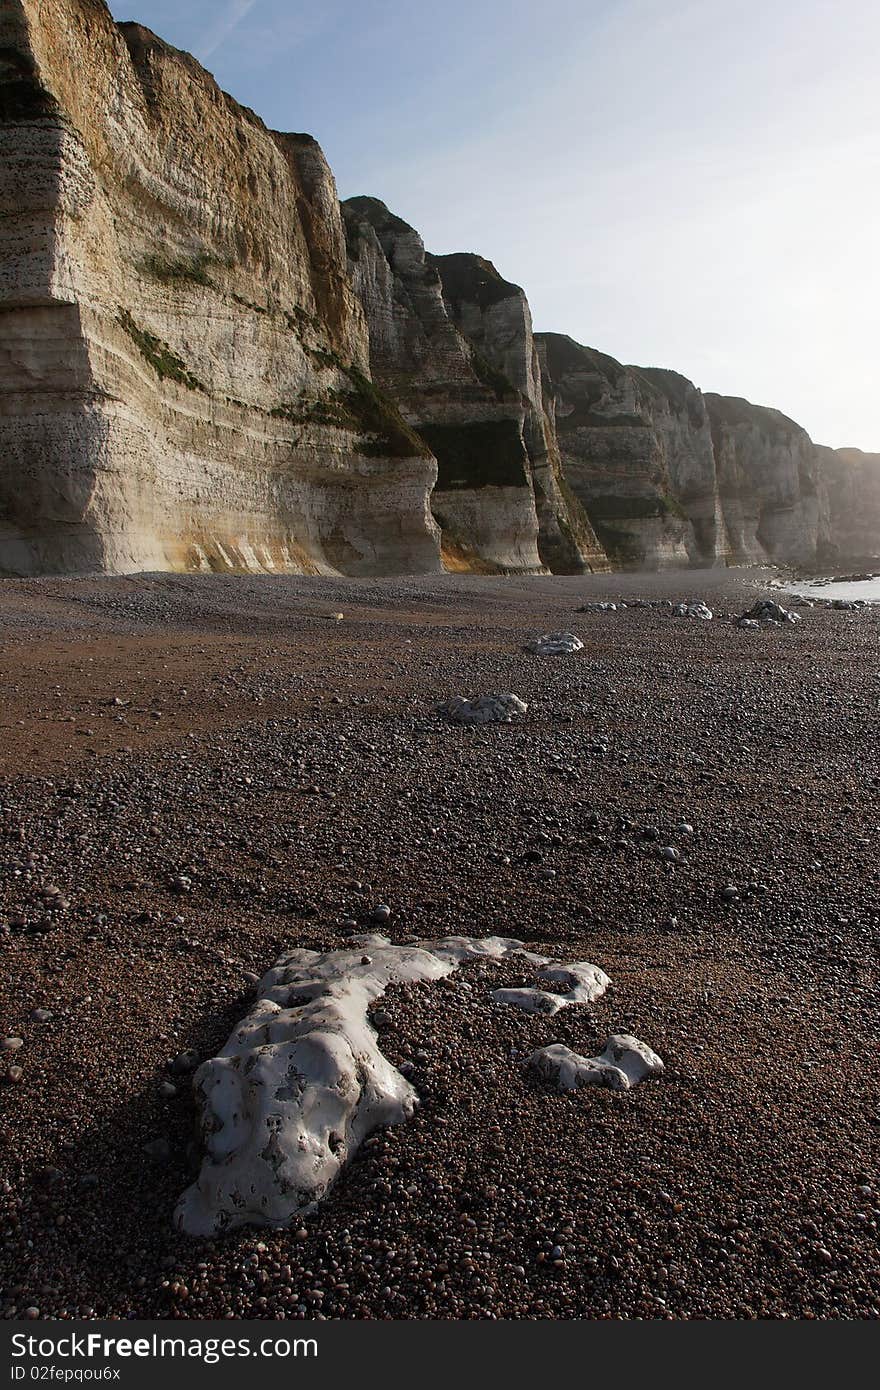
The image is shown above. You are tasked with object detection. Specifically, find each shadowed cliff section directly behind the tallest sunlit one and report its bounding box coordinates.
[343,197,606,573]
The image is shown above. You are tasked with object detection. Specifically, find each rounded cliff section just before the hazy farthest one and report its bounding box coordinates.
[705,393,829,564]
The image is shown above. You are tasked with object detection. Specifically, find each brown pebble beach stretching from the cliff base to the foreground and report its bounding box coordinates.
[0,571,880,1319]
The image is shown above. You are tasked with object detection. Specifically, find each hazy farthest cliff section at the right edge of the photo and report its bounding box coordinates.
[819,449,880,560]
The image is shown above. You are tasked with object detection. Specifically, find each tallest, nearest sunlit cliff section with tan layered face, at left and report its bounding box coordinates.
[0,0,439,574]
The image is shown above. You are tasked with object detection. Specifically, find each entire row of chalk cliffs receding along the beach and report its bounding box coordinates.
[0,0,880,574]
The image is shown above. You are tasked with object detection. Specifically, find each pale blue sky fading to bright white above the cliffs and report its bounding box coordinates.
[111,0,880,452]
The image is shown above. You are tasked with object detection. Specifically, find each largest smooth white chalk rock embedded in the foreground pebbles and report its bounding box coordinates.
[175,934,569,1236]
